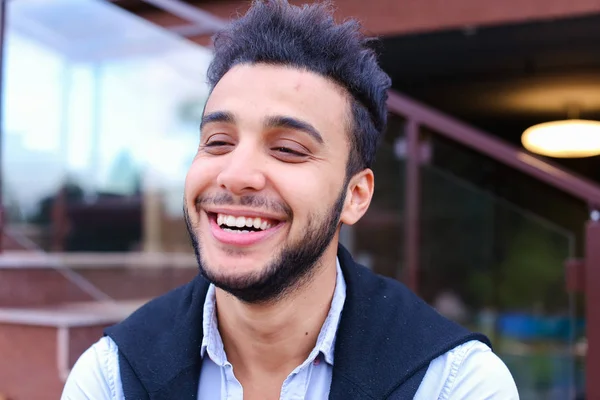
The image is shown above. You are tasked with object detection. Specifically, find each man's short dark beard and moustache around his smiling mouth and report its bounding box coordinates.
[183,182,348,304]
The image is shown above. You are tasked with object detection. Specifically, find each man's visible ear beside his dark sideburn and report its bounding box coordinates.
[340,168,375,225]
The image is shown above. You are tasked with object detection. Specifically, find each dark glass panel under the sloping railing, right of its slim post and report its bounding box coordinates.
[419,141,583,399]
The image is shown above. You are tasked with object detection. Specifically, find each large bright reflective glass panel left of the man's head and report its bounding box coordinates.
[3,0,212,251]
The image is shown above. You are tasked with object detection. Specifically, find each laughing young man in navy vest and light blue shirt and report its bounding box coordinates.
[63,0,518,400]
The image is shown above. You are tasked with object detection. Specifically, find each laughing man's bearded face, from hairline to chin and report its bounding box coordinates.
[184,64,349,302]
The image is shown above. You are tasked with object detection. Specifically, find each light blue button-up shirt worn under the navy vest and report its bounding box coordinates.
[61,262,519,400]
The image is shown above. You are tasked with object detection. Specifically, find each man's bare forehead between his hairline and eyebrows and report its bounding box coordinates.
[205,64,349,140]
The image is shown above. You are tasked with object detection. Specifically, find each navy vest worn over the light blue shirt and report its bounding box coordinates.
[105,246,491,400]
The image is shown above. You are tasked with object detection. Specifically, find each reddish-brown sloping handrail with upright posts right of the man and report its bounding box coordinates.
[387,91,600,399]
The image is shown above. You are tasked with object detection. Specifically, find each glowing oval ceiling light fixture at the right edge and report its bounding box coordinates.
[521,119,600,158]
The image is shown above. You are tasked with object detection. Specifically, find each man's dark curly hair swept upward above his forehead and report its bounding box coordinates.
[208,0,391,177]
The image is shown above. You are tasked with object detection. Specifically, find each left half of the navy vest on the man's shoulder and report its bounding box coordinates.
[105,275,208,398]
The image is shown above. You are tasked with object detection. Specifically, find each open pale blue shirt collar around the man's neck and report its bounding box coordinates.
[200,258,346,366]
